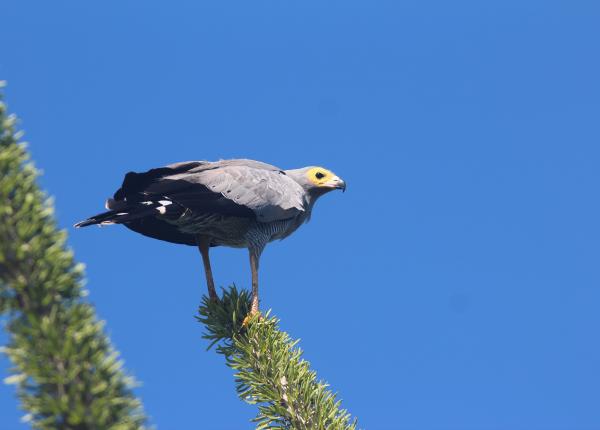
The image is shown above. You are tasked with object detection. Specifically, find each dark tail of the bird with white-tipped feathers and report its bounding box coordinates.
[73,199,172,228]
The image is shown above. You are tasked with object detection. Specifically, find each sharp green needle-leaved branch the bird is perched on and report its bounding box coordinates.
[198,286,356,430]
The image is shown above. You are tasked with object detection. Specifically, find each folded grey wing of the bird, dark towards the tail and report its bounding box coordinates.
[113,160,304,222]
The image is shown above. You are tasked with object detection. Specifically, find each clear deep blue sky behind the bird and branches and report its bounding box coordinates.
[0,0,600,430]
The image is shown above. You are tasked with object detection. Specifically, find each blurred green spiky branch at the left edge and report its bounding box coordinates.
[0,84,145,430]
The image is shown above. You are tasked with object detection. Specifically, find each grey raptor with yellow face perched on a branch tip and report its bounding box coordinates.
[74,159,346,315]
